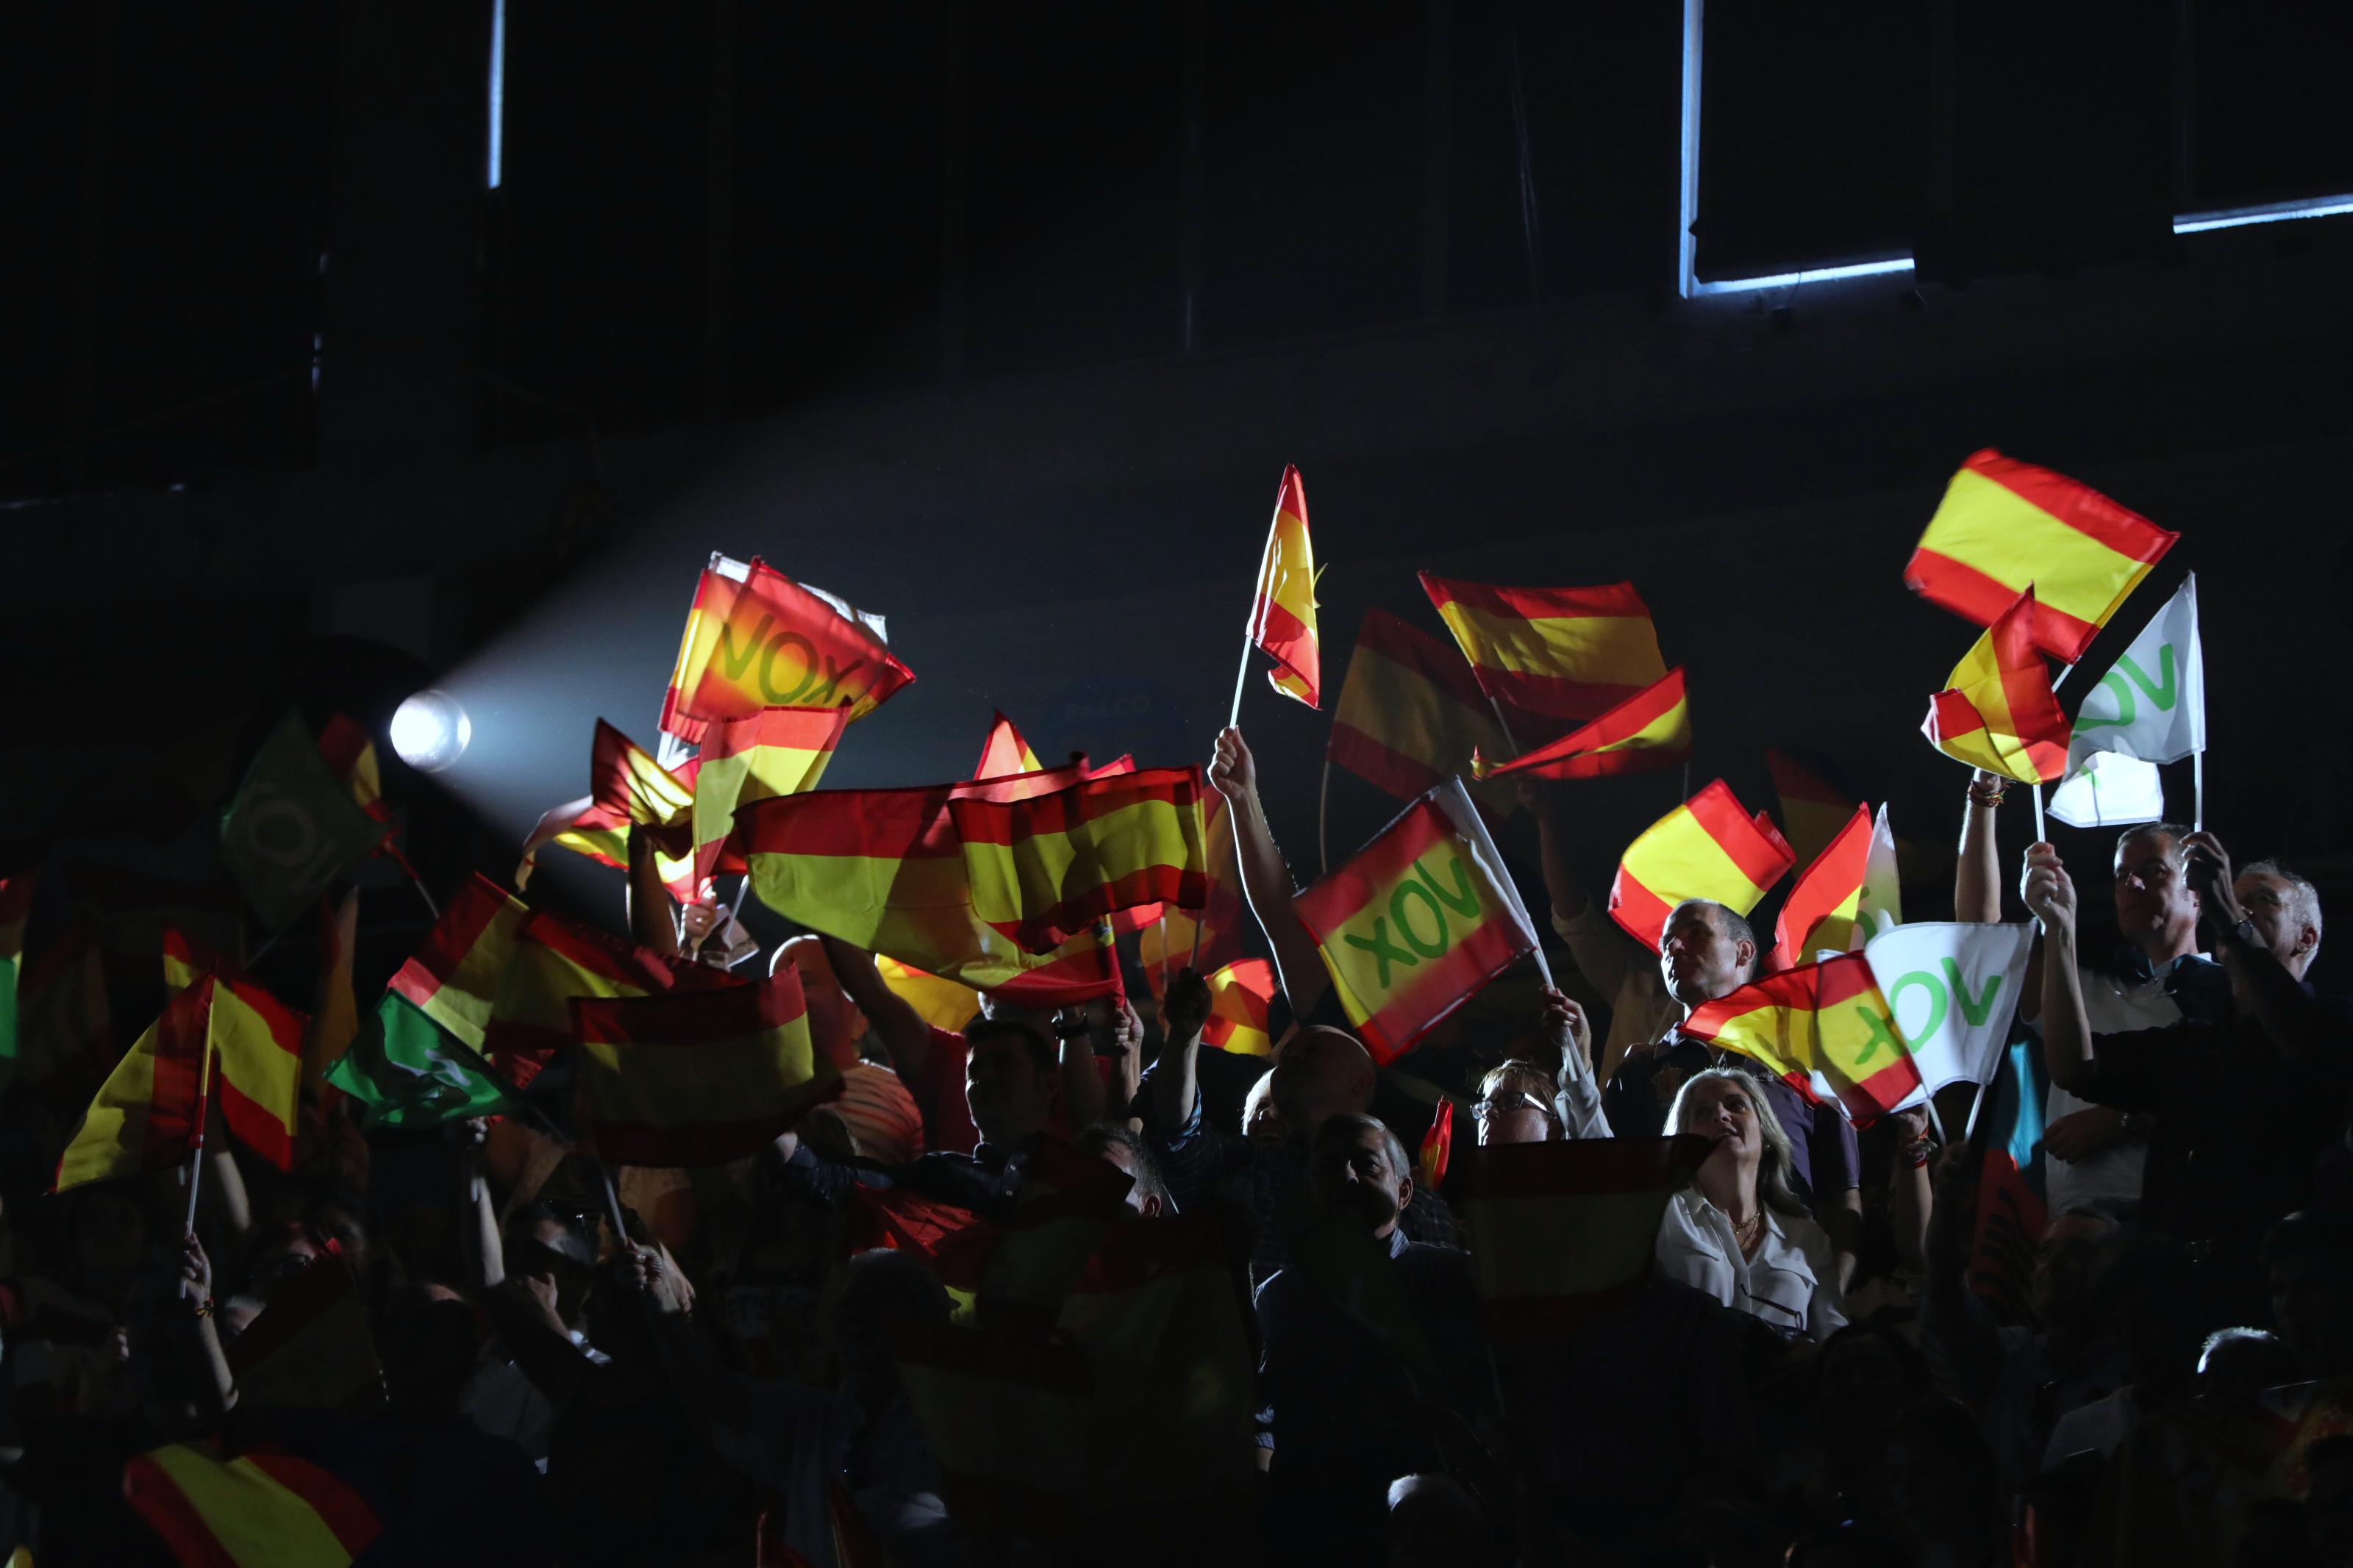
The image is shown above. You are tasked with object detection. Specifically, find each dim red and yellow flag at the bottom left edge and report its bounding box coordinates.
[122,1441,384,1568]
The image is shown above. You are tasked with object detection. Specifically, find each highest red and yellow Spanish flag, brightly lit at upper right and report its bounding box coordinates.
[1904,447,2181,663]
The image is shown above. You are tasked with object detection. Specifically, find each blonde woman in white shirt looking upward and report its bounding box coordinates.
[1659,1067,1847,1342]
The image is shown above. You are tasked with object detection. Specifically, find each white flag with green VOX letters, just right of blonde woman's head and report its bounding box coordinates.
[1863,922,2033,1093]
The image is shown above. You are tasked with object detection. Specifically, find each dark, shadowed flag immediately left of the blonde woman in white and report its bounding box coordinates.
[1454,1133,1710,1342]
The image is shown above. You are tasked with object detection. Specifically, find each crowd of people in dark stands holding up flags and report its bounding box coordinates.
[0,731,2353,1568]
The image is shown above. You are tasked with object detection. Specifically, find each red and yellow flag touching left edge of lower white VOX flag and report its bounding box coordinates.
[1682,952,1922,1121]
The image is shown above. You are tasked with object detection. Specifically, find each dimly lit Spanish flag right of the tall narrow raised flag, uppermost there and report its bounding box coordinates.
[1421,571,1666,745]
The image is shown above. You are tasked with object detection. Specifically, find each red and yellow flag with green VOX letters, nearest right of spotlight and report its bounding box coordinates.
[661,555,915,743]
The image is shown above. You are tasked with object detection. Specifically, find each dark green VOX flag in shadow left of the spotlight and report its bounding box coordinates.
[221,715,390,931]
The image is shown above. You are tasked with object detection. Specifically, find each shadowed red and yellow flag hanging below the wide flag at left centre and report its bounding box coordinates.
[572,964,843,1166]
